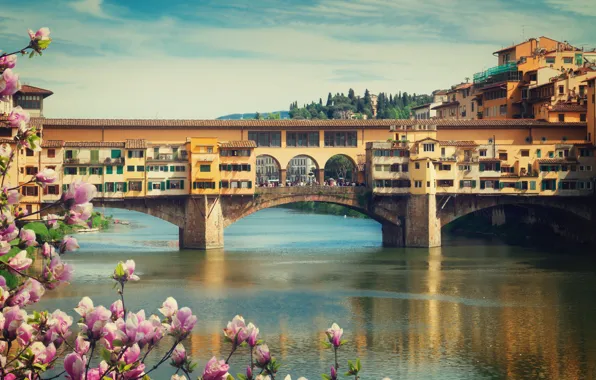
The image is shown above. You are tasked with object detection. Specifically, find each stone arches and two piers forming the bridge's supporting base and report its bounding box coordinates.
[94,186,596,249]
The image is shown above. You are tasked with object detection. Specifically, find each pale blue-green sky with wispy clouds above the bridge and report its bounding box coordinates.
[0,0,596,119]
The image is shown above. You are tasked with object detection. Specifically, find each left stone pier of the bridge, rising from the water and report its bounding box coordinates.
[179,195,224,249]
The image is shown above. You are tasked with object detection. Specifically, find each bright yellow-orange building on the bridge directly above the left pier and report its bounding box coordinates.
[188,137,221,195]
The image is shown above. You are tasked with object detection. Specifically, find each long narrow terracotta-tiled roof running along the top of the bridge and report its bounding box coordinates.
[31,118,586,129]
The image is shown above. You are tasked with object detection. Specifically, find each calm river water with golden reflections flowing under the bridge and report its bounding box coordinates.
[39,209,596,380]
